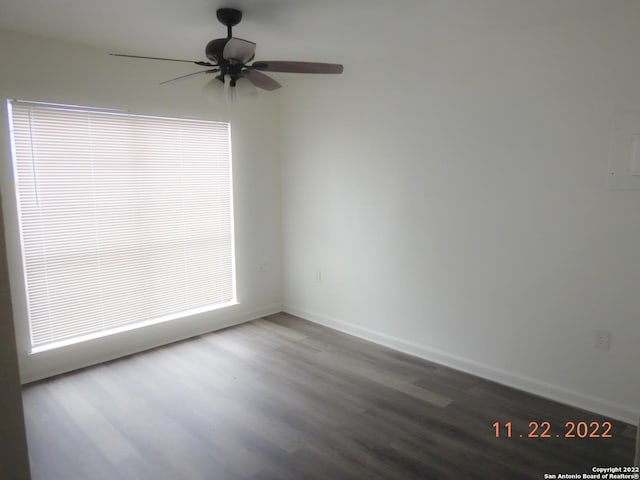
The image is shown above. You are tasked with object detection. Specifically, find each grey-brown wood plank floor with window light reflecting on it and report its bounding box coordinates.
[23,314,636,480]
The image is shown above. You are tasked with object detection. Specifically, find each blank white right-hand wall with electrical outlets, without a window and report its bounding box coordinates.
[281,0,640,423]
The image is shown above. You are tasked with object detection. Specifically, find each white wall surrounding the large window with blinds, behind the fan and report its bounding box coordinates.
[0,31,282,381]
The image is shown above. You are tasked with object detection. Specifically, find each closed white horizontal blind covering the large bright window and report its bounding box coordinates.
[10,102,235,351]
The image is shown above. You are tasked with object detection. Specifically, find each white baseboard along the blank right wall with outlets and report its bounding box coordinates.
[283,305,640,425]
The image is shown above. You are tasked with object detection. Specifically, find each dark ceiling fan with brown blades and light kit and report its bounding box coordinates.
[111,8,343,91]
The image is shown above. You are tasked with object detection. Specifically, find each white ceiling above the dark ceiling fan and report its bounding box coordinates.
[0,0,633,65]
